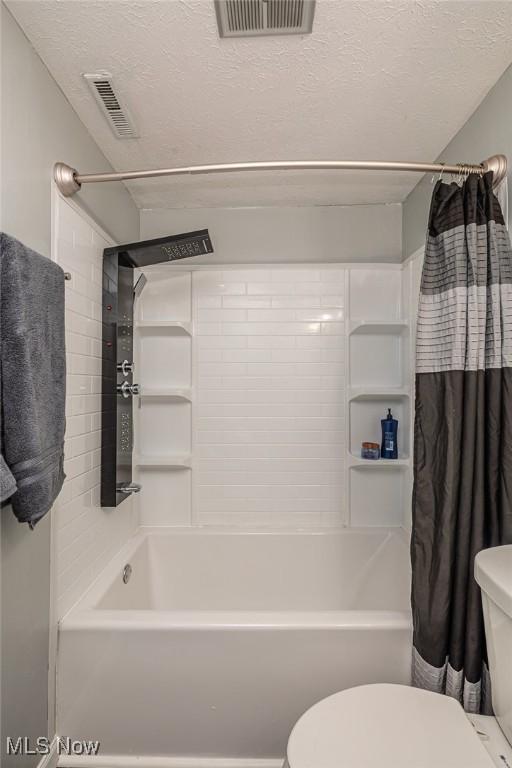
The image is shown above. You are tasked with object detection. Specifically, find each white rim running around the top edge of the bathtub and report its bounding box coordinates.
[59,526,412,632]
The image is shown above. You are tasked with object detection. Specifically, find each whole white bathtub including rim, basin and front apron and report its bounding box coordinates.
[57,528,411,765]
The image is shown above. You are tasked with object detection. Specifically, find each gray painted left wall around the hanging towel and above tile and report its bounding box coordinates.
[0,5,139,768]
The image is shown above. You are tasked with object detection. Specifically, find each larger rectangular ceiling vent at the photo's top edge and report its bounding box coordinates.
[215,0,315,37]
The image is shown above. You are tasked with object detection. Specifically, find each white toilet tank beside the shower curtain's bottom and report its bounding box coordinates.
[475,545,512,744]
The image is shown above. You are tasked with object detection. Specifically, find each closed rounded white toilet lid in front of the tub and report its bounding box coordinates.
[287,685,493,768]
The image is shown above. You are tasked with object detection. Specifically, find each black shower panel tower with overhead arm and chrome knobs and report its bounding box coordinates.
[101,229,213,507]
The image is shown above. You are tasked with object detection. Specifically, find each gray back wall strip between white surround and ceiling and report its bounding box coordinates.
[140,205,402,264]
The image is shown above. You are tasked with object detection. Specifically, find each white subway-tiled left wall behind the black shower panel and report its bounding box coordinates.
[55,196,135,618]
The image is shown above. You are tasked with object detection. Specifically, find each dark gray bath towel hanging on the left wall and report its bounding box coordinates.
[0,233,66,528]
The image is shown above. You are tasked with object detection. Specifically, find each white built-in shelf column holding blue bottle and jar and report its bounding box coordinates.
[347,266,411,526]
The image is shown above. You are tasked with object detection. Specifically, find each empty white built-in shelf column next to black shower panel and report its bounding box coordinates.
[134,265,193,525]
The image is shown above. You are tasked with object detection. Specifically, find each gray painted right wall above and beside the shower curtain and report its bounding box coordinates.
[402,62,512,258]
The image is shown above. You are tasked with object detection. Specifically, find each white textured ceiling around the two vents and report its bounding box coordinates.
[8,0,512,208]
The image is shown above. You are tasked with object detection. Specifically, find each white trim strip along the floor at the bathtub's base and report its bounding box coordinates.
[59,755,284,768]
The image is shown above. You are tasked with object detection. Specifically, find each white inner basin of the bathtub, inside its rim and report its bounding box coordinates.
[90,530,410,612]
